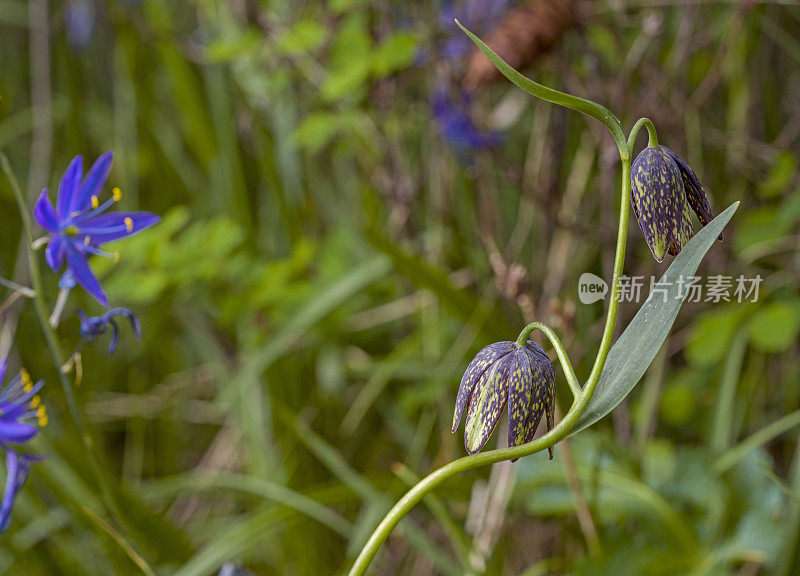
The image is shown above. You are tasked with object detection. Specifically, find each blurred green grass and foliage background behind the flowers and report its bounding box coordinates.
[0,0,800,576]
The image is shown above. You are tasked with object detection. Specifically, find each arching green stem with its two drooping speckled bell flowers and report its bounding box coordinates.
[349,22,735,576]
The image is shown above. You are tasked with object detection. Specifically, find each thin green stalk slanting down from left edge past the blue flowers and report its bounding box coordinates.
[0,152,155,576]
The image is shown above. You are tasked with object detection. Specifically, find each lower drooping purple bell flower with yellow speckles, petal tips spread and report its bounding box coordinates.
[452,340,556,458]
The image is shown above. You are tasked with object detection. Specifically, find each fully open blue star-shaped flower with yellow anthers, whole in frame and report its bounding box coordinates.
[34,152,159,306]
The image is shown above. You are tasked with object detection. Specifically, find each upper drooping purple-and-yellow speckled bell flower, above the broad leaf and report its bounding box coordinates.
[631,146,722,262]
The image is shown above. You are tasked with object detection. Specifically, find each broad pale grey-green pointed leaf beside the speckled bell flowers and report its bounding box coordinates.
[572,202,739,434]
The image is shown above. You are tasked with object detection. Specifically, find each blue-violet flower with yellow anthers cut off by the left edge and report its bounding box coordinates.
[0,359,47,532]
